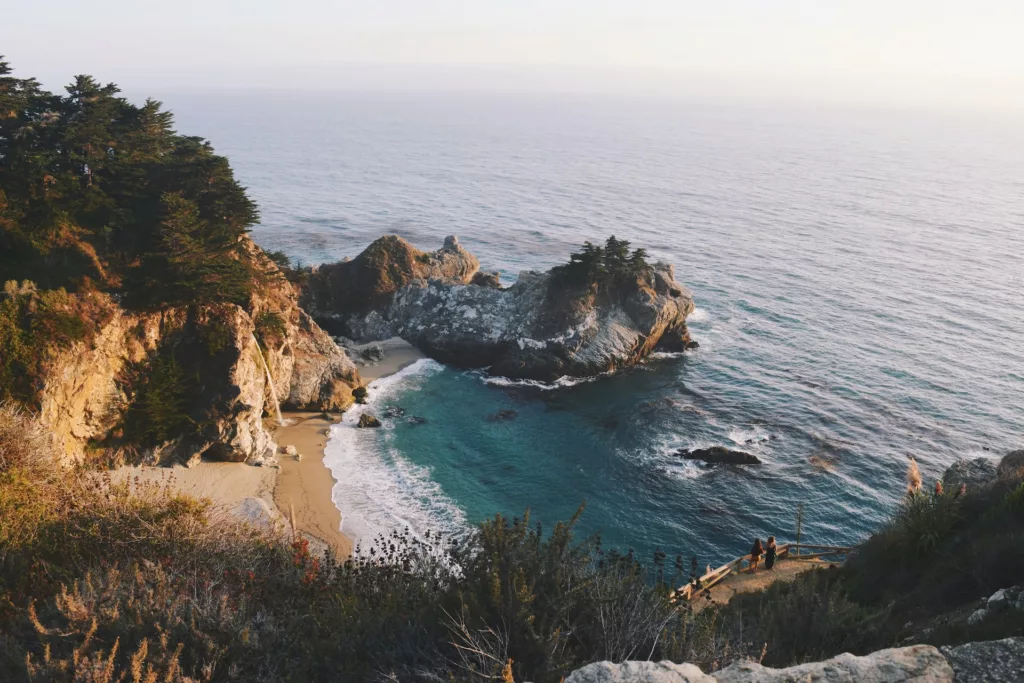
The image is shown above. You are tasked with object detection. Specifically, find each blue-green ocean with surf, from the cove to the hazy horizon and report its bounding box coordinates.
[169,92,1024,566]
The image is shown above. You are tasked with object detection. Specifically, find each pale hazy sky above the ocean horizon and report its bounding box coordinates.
[0,0,1024,109]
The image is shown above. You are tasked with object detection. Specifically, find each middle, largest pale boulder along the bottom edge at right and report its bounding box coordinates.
[713,645,953,683]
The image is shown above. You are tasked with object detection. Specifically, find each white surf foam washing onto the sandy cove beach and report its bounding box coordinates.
[324,359,468,545]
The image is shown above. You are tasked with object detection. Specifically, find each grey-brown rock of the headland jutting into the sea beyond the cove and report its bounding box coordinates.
[302,237,693,381]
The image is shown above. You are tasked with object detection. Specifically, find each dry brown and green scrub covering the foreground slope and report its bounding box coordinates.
[0,397,1024,682]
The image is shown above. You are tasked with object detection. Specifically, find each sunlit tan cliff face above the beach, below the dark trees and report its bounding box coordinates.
[33,237,360,464]
